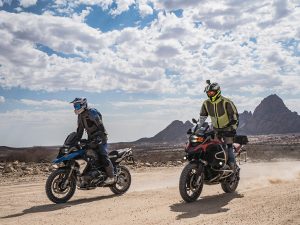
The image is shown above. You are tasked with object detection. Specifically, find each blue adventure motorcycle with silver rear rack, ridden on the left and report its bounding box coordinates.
[45,132,134,203]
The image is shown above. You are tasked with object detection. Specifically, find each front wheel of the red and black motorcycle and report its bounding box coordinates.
[179,163,203,202]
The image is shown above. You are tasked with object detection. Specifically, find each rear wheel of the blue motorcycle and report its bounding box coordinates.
[110,166,131,195]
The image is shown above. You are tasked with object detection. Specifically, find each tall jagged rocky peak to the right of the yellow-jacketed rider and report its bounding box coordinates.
[238,94,300,135]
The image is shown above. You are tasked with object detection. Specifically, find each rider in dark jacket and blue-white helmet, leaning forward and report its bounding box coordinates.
[70,98,115,185]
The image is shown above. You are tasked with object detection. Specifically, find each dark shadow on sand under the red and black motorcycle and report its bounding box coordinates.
[170,193,244,220]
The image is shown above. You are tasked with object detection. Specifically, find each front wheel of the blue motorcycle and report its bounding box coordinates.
[45,169,76,203]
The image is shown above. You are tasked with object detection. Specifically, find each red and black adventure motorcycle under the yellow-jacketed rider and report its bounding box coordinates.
[179,119,248,202]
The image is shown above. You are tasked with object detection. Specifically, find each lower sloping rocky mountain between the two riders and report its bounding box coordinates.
[136,120,193,144]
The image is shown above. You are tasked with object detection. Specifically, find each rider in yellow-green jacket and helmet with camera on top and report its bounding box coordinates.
[199,80,239,171]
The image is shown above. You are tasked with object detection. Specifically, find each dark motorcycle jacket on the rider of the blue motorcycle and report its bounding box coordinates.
[77,108,107,144]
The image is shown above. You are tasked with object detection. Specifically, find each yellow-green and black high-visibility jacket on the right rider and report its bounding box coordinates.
[200,96,239,130]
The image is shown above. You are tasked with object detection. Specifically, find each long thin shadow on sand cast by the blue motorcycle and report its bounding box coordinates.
[1,194,118,219]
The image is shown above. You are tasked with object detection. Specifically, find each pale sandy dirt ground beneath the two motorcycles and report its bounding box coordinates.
[0,161,300,225]
